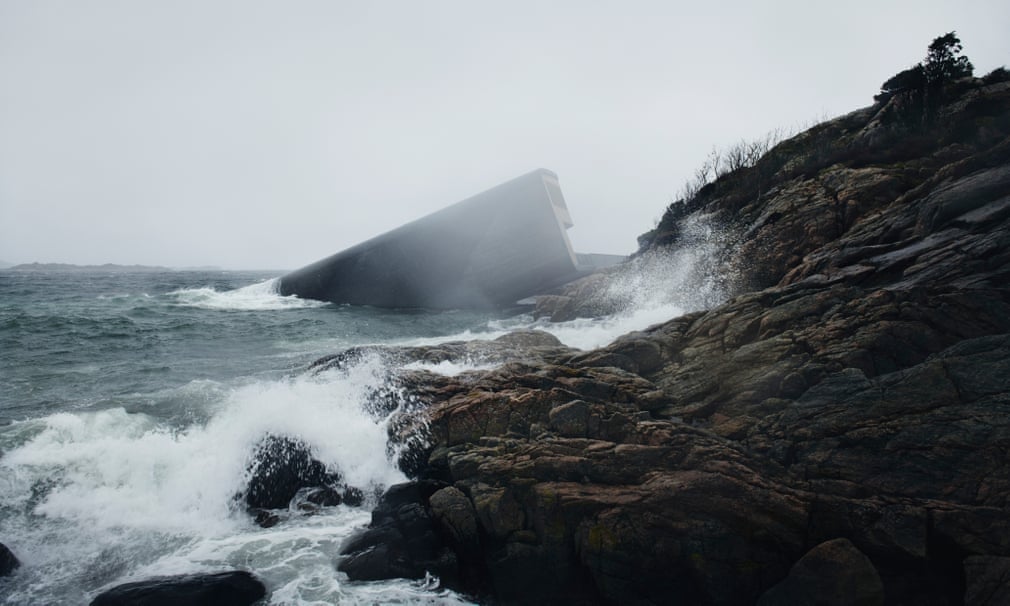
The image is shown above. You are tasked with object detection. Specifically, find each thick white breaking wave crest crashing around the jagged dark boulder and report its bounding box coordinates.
[2,355,403,534]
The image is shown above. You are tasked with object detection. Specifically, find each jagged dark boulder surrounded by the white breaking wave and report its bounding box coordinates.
[243,435,364,528]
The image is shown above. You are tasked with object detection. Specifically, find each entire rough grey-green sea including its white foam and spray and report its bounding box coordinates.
[0,236,723,605]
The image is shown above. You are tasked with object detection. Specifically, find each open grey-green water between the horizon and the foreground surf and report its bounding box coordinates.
[0,272,502,420]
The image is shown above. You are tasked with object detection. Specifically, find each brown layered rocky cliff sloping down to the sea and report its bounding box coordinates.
[339,80,1010,605]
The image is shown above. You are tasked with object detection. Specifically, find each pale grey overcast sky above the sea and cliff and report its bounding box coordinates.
[0,0,1010,269]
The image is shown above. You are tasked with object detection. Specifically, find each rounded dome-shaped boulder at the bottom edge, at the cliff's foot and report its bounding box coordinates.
[758,538,884,606]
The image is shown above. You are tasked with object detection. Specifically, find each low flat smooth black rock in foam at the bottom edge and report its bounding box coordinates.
[91,571,267,606]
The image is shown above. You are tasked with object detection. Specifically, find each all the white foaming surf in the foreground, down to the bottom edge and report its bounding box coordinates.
[0,353,422,604]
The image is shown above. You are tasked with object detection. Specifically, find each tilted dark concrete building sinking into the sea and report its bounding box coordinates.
[280,169,624,309]
